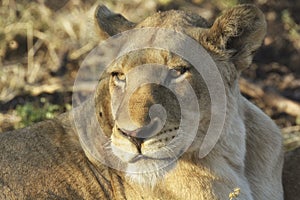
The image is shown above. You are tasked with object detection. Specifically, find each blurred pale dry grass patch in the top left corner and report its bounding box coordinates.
[0,2,97,102]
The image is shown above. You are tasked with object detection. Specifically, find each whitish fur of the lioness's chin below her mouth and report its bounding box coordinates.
[126,159,176,189]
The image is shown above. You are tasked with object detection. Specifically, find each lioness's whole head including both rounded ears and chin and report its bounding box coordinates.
[95,5,265,185]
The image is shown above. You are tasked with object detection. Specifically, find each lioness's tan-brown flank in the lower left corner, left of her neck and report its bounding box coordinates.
[0,117,111,199]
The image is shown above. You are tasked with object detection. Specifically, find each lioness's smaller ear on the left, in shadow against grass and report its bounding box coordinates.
[95,5,135,37]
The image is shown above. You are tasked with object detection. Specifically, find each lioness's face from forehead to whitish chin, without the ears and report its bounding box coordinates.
[96,49,210,183]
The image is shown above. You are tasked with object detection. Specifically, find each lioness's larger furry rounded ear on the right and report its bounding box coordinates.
[205,4,266,70]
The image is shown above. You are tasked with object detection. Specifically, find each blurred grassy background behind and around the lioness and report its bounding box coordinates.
[0,0,300,151]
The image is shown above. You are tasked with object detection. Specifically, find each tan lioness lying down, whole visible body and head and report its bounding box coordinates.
[0,5,283,200]
